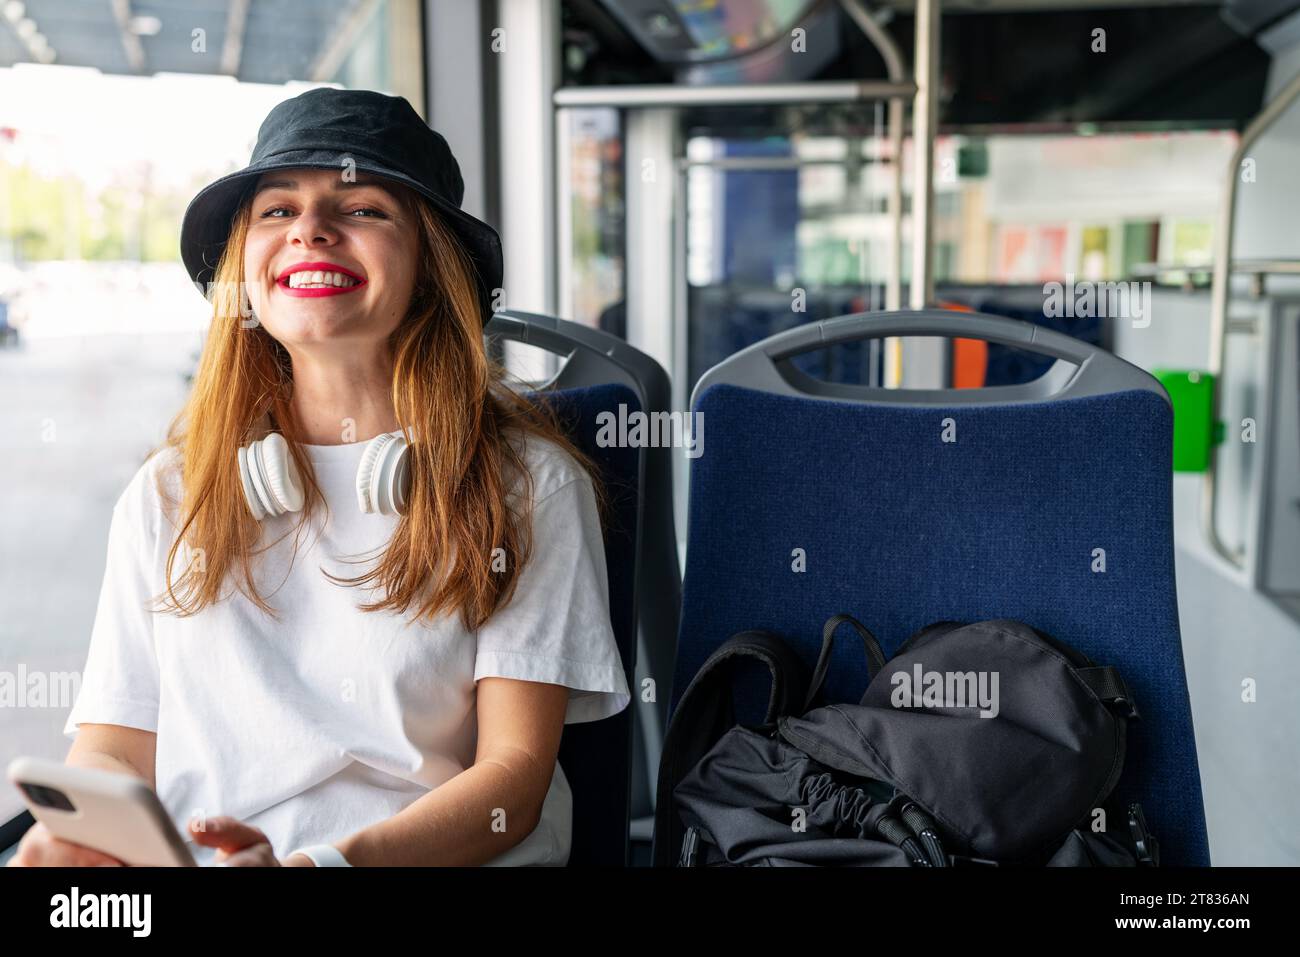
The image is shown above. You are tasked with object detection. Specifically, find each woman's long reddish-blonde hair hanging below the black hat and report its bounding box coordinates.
[156,183,606,631]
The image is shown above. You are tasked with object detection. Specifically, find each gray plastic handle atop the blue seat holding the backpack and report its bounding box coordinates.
[692,309,1169,407]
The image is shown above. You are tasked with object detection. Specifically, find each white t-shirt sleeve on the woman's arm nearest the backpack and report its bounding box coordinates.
[475,473,631,724]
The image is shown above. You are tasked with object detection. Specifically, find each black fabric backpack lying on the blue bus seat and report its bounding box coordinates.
[654,615,1158,867]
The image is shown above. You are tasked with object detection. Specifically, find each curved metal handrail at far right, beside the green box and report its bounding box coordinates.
[1201,74,1300,568]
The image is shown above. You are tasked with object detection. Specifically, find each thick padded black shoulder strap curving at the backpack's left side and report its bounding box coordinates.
[651,631,809,867]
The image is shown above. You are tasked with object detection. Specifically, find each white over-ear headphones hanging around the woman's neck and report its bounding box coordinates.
[239,432,411,521]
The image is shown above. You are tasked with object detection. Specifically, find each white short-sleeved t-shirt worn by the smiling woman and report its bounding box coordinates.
[64,433,631,865]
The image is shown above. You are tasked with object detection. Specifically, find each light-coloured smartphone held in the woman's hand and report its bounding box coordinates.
[9,758,196,867]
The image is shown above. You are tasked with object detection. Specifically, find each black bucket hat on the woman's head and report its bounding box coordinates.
[181,87,503,320]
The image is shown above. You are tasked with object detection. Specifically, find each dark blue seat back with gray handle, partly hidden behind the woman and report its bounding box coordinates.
[486,311,680,866]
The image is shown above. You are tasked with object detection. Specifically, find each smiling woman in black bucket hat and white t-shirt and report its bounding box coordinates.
[14,90,629,866]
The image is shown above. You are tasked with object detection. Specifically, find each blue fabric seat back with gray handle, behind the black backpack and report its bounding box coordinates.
[657,311,1209,865]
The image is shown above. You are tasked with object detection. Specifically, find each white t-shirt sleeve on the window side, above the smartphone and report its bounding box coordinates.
[64,476,159,736]
